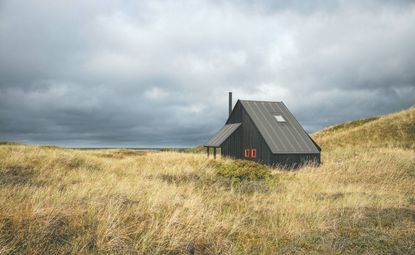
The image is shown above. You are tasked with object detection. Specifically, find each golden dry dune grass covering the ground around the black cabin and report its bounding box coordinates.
[0,109,415,254]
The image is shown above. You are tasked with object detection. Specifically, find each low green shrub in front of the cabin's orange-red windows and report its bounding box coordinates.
[213,160,272,181]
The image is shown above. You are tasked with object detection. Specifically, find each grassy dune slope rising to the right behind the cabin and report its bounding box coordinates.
[312,107,415,149]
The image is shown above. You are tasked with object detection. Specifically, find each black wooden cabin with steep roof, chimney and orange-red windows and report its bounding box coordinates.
[205,93,321,168]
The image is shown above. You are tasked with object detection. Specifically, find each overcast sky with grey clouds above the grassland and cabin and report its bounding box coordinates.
[0,0,415,147]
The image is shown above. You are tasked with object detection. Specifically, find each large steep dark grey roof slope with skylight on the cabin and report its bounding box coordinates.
[239,100,320,153]
